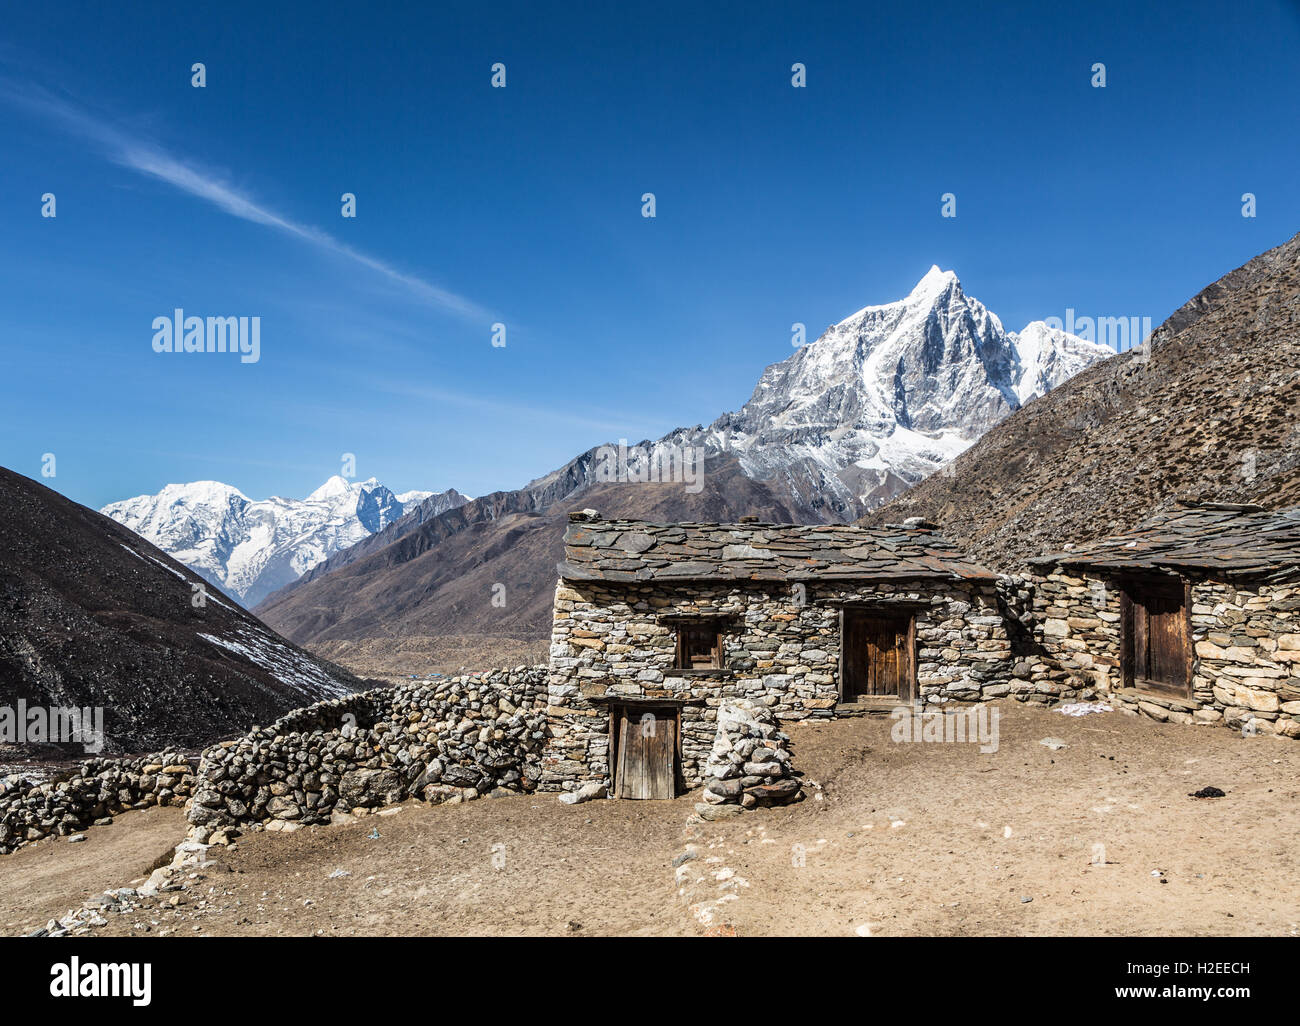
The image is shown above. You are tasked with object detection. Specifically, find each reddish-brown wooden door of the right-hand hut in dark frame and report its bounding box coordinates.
[1123,577,1192,698]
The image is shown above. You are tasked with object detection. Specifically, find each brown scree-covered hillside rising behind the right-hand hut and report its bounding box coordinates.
[865,235,1300,568]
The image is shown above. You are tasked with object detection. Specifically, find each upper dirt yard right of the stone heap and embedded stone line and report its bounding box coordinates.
[712,704,1300,936]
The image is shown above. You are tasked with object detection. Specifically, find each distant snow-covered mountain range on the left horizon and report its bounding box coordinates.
[100,475,465,607]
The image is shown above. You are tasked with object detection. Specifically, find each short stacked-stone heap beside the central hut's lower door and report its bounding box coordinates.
[696,700,801,819]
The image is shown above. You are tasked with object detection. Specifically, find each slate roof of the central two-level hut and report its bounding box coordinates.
[556,511,996,583]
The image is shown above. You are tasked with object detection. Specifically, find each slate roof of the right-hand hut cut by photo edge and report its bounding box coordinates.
[1030,502,1300,579]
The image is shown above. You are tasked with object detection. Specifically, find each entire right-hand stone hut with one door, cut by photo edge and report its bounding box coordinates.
[1031,502,1300,737]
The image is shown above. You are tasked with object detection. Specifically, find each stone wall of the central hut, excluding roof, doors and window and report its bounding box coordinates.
[541,581,1040,791]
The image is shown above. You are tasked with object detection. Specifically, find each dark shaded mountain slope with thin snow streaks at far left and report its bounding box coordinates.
[0,468,361,752]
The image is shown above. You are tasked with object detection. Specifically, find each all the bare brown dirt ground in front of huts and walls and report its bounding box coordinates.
[10,702,1300,936]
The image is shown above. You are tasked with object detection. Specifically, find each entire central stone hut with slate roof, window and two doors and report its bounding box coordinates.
[541,510,1015,797]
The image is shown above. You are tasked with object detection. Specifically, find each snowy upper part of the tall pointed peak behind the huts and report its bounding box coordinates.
[663,265,1113,519]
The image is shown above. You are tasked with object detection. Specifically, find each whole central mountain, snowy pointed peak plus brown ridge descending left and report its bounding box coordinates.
[257,268,1112,658]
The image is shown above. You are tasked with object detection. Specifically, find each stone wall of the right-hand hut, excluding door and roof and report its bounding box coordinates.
[1032,567,1300,737]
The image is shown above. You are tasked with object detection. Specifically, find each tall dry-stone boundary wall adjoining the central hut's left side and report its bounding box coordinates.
[189,666,546,831]
